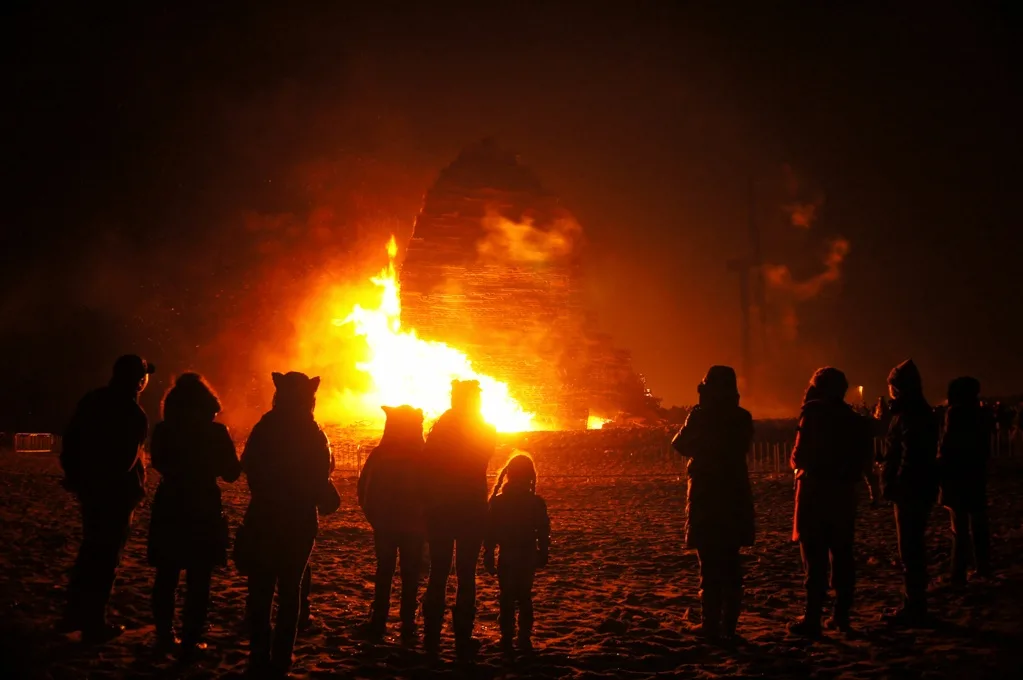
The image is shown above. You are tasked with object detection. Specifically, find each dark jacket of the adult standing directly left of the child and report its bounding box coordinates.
[422,410,497,531]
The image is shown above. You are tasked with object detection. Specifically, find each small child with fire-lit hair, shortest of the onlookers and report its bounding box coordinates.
[483,454,550,653]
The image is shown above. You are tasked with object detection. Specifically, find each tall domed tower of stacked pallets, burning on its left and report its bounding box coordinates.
[401,140,643,427]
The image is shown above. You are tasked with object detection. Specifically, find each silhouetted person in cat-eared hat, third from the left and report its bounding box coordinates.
[234,372,340,674]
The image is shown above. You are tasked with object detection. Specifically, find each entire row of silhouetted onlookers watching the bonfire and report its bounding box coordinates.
[49,355,992,677]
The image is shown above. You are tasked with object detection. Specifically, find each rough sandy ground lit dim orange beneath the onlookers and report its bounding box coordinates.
[0,429,1023,678]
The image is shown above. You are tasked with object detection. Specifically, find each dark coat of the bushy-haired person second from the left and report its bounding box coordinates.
[147,420,241,569]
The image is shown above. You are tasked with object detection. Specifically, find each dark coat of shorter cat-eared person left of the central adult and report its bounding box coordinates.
[359,436,427,536]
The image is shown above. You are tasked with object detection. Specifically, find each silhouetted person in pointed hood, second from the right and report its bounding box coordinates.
[882,360,938,625]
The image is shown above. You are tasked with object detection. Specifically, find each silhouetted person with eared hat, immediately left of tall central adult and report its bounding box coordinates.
[359,406,427,645]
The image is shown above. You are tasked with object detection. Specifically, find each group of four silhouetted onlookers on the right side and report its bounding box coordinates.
[674,361,991,638]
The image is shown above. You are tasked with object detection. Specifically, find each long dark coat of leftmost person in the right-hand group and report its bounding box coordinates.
[672,405,755,549]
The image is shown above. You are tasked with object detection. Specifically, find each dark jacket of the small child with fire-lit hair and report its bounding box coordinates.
[484,485,550,571]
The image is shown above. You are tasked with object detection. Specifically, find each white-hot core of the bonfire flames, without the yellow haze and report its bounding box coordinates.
[333,236,535,432]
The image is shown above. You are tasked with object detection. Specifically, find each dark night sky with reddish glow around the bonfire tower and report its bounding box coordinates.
[0,2,1023,428]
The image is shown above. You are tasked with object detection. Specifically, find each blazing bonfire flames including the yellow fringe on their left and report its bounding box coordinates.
[310,236,536,432]
